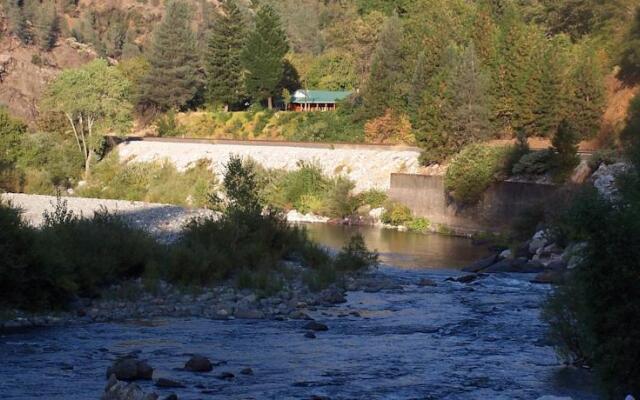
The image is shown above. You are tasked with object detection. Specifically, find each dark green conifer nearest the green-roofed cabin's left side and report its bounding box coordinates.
[241,5,289,109]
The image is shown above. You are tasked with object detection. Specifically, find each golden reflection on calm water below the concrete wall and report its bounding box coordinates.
[305,224,488,269]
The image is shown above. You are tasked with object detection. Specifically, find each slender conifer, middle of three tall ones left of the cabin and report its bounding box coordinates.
[206,0,245,110]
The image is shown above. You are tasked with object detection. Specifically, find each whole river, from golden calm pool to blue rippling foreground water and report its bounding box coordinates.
[0,225,597,400]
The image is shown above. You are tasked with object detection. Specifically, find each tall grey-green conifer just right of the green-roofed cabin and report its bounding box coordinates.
[363,16,406,117]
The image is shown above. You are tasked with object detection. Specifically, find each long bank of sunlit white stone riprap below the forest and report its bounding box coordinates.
[118,141,420,192]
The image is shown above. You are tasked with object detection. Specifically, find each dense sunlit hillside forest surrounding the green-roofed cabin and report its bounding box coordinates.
[3,0,640,190]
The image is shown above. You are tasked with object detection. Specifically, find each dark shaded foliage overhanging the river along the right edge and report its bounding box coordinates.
[544,101,640,398]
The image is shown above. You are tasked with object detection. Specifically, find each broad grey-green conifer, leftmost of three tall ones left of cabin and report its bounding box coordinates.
[139,0,200,111]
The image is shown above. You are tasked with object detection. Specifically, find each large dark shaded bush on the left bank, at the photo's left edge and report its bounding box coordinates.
[0,201,164,309]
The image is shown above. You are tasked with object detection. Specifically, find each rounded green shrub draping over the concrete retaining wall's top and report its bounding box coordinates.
[444,144,510,205]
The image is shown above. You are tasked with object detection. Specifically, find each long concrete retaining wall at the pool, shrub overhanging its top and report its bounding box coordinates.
[389,174,557,233]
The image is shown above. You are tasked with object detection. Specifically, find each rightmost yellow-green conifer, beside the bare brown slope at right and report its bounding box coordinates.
[566,47,605,139]
